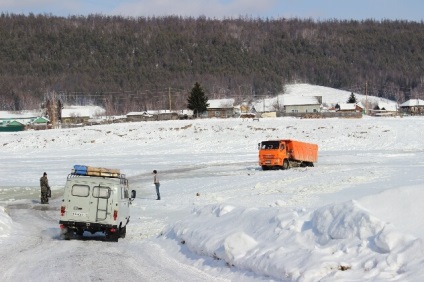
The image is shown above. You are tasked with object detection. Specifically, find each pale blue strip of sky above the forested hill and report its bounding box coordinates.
[0,0,424,22]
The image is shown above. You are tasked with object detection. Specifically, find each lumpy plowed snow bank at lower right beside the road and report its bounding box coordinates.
[165,201,424,281]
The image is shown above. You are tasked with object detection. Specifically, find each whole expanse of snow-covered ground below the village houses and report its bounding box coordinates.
[0,85,424,281]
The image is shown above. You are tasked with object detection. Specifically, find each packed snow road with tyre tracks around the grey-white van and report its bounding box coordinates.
[0,191,232,281]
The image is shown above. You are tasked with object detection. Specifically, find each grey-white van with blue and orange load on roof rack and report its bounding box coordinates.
[59,165,135,241]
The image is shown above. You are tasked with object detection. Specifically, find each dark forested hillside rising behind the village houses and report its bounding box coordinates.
[0,14,424,113]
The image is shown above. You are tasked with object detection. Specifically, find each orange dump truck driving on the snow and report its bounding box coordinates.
[258,140,318,170]
